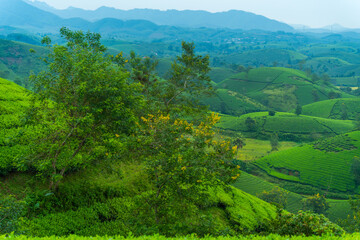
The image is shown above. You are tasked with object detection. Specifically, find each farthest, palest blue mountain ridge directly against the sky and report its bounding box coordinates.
[28,0,293,31]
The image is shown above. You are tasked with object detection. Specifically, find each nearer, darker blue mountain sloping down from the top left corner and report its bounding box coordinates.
[0,0,165,36]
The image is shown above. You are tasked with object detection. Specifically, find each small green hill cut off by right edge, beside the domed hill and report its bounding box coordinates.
[302,98,360,120]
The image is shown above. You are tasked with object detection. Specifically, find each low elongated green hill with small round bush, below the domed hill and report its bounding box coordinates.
[217,112,355,141]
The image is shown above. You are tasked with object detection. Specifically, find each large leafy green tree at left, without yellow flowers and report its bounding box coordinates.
[22,28,141,189]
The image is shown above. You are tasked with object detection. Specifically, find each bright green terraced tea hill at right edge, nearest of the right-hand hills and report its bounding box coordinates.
[255,131,360,193]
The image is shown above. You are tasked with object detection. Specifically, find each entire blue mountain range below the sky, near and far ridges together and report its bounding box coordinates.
[0,0,293,32]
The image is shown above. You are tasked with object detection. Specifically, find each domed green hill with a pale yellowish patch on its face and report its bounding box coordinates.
[217,67,352,111]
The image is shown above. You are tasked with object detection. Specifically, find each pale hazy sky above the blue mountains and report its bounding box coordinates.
[31,0,360,28]
